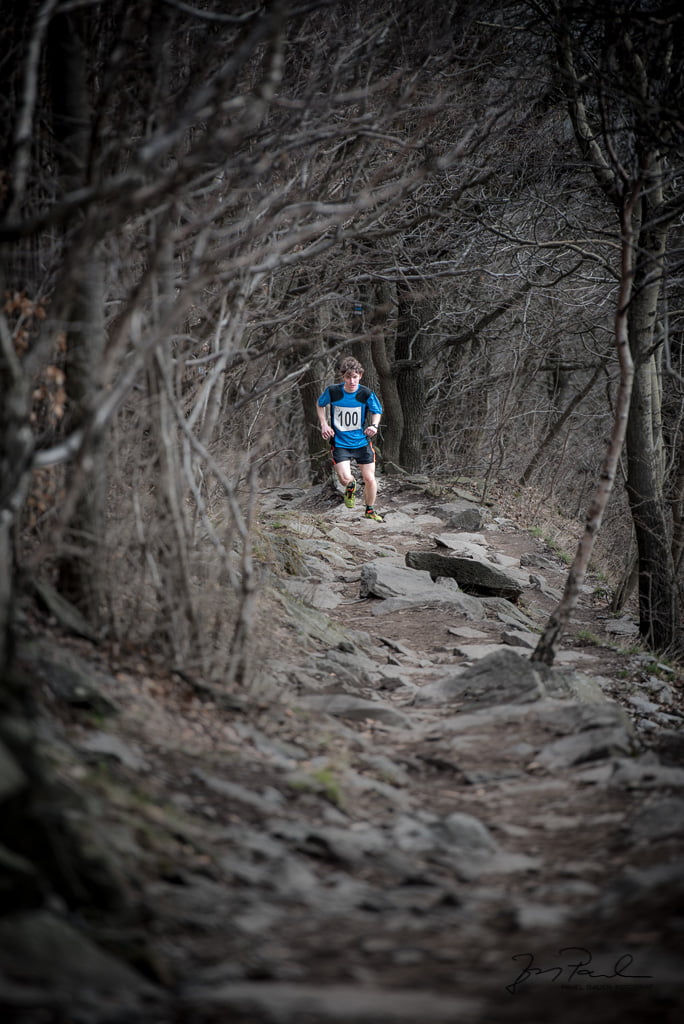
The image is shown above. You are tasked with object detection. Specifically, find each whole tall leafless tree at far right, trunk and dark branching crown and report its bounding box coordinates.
[535,2,684,650]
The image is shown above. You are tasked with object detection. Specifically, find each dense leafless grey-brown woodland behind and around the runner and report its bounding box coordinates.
[0,0,684,685]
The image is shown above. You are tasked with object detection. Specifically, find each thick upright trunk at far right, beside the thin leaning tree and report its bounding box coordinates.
[556,5,682,650]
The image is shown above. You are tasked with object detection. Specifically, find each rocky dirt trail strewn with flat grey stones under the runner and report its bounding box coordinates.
[0,481,684,1024]
